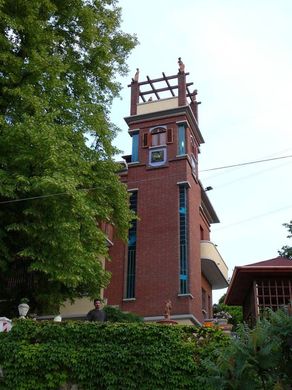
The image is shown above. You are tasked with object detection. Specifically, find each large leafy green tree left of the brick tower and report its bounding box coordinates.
[0,0,136,313]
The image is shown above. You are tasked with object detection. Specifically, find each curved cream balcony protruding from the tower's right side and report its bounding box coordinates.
[201,241,228,290]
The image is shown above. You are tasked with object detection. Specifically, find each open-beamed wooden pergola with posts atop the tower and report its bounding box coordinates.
[128,57,200,118]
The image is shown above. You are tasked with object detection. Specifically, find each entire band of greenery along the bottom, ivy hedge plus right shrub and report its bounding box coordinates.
[0,311,292,390]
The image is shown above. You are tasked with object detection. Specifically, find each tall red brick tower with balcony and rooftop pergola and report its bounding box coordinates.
[105,58,227,323]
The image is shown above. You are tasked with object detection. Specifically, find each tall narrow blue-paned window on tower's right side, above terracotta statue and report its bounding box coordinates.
[179,185,188,294]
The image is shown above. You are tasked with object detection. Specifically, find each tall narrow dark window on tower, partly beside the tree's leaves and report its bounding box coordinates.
[126,191,137,299]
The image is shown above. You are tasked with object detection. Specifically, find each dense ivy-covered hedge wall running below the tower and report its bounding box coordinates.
[0,320,229,390]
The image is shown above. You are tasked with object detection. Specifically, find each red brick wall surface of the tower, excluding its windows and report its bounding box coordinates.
[105,110,210,321]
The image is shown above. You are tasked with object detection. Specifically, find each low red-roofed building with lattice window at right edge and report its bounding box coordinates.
[225,256,292,325]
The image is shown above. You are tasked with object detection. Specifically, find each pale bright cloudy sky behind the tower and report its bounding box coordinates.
[111,0,292,302]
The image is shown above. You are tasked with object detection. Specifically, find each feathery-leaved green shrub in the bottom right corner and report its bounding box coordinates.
[202,311,292,390]
